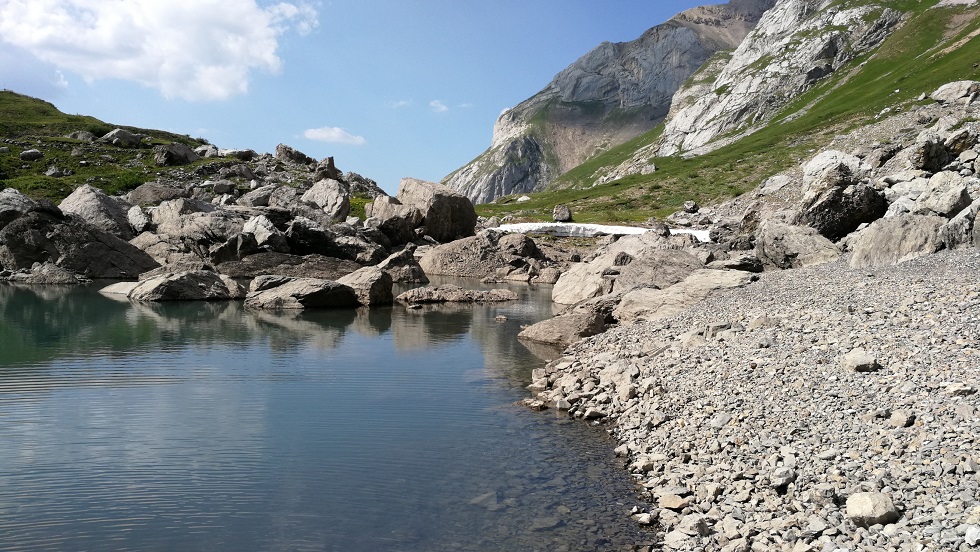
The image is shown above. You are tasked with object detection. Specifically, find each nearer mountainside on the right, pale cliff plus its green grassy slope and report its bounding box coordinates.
[468,0,980,222]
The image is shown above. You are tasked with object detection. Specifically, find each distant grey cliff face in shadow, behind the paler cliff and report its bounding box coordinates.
[443,0,775,203]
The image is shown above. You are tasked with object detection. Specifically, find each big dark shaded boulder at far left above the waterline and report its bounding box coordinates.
[0,211,158,280]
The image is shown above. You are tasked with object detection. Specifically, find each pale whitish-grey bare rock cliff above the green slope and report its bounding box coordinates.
[649,0,903,156]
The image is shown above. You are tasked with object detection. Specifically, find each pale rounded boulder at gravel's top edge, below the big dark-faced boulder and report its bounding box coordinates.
[755,220,840,268]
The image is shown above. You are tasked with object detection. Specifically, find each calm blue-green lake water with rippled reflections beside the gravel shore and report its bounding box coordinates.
[0,285,651,551]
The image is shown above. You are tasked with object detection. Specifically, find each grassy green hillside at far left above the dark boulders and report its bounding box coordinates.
[0,90,204,202]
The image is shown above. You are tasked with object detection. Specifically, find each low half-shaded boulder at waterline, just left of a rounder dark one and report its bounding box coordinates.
[245,278,360,310]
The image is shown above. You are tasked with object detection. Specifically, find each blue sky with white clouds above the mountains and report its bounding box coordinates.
[0,0,706,194]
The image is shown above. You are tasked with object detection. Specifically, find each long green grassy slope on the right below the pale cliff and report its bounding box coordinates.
[478,0,980,222]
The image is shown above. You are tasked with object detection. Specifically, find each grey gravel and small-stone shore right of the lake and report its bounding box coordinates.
[531,249,980,552]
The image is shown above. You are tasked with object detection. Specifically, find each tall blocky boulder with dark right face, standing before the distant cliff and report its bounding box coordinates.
[398,178,476,243]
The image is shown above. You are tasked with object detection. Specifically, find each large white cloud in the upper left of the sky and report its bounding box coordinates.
[0,0,318,100]
